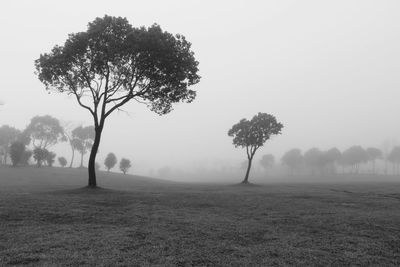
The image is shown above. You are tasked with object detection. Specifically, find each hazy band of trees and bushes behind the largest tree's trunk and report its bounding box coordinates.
[0,115,131,174]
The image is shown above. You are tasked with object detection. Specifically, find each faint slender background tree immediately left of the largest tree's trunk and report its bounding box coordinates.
[72,126,95,168]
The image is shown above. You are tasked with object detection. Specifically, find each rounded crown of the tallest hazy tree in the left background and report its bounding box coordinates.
[24,115,66,149]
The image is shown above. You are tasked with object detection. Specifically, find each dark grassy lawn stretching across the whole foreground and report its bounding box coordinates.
[0,167,400,266]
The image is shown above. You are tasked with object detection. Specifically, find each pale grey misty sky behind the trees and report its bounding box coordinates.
[0,0,400,172]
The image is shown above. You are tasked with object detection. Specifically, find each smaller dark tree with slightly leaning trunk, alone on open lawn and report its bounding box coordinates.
[228,112,283,184]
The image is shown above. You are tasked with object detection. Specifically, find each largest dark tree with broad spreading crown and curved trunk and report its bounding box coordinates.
[35,15,200,187]
